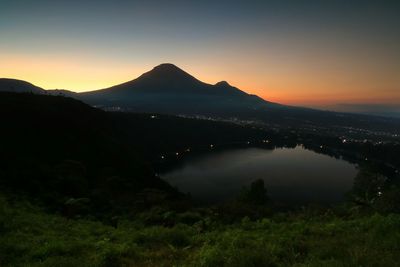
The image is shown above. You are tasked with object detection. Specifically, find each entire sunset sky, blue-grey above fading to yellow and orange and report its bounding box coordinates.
[0,0,400,106]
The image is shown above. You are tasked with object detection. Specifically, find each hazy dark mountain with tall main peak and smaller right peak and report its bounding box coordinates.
[79,64,277,116]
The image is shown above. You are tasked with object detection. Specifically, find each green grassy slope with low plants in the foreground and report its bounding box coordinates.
[0,197,400,267]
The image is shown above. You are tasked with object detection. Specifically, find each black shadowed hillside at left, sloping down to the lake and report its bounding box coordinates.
[0,93,178,215]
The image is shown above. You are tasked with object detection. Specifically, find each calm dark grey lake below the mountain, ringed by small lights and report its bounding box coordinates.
[161,146,357,204]
